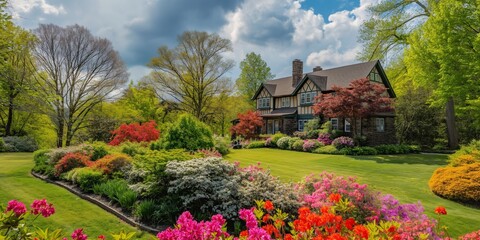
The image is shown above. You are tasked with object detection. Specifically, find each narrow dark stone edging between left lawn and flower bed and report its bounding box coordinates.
[30,171,165,234]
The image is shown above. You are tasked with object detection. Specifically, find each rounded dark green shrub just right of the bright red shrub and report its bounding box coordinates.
[165,114,213,151]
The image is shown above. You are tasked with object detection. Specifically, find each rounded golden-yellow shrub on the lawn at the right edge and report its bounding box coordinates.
[428,162,480,203]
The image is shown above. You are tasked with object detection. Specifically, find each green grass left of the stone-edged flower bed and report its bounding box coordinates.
[0,153,153,239]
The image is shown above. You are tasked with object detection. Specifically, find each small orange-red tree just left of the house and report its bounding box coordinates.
[230,110,263,139]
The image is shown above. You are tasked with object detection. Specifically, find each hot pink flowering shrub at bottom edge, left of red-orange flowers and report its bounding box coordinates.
[157,212,230,240]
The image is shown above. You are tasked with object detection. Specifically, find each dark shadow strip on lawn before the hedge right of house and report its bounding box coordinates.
[351,154,448,165]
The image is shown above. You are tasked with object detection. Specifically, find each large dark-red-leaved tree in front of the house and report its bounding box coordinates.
[313,78,393,136]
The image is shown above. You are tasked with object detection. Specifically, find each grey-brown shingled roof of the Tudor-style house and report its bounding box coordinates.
[252,60,395,99]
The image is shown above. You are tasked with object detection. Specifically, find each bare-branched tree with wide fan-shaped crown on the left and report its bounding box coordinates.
[34,24,128,147]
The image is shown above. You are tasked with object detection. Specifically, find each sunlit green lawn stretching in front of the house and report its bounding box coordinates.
[227,148,480,236]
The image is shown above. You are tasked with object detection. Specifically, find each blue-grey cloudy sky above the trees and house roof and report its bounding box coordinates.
[10,0,378,81]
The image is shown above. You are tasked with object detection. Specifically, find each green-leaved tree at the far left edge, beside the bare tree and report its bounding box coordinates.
[0,24,36,136]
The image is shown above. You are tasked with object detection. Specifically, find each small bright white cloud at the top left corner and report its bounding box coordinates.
[11,0,67,16]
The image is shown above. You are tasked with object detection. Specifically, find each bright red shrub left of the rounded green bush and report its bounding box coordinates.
[108,120,160,146]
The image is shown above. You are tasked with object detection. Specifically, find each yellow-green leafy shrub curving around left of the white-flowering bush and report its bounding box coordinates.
[128,149,196,199]
